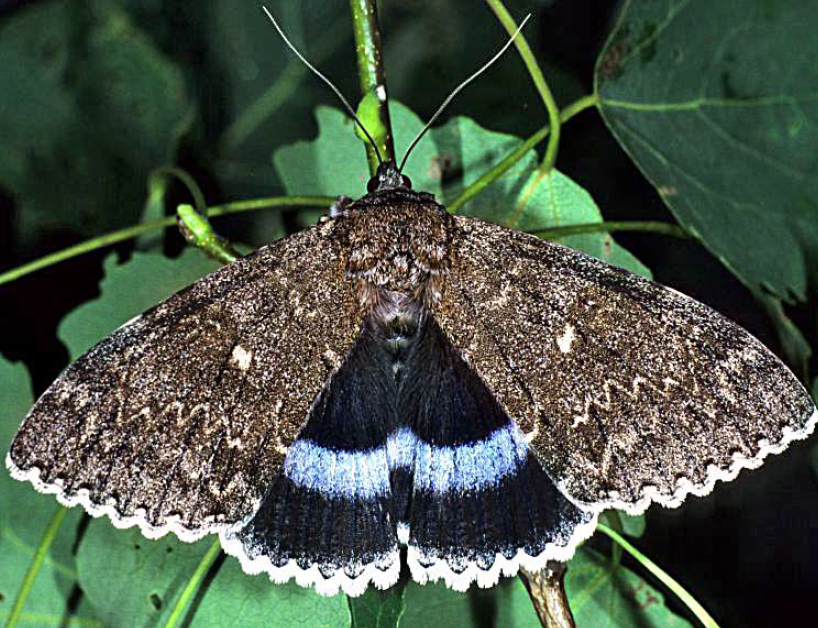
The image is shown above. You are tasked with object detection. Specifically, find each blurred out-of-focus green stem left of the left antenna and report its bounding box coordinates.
[219,21,347,154]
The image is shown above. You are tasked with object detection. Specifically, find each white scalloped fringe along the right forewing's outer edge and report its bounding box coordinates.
[552,406,818,515]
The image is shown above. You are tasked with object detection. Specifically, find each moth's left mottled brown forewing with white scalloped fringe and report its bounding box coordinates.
[8,224,361,539]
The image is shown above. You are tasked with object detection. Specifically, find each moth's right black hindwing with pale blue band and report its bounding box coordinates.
[390,318,596,591]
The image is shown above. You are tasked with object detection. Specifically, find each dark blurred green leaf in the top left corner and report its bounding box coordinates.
[0,0,192,244]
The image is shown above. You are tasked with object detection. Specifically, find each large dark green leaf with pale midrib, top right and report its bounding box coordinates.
[596,0,818,300]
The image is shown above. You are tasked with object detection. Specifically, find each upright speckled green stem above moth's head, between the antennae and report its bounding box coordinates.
[349,0,395,175]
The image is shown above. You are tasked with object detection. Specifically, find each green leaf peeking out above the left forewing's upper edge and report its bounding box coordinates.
[57,248,221,359]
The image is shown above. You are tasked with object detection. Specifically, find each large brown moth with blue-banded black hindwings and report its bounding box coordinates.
[6,9,818,595]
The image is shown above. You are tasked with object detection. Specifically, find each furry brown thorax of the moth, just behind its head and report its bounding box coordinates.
[333,189,455,312]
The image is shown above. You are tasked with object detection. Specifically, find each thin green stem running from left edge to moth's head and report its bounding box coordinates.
[0,196,335,284]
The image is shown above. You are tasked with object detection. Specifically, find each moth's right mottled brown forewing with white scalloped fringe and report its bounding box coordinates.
[436,217,816,512]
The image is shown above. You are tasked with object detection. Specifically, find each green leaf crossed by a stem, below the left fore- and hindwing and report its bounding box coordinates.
[72,520,349,628]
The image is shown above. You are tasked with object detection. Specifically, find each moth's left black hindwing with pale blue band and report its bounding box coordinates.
[225,325,400,595]
